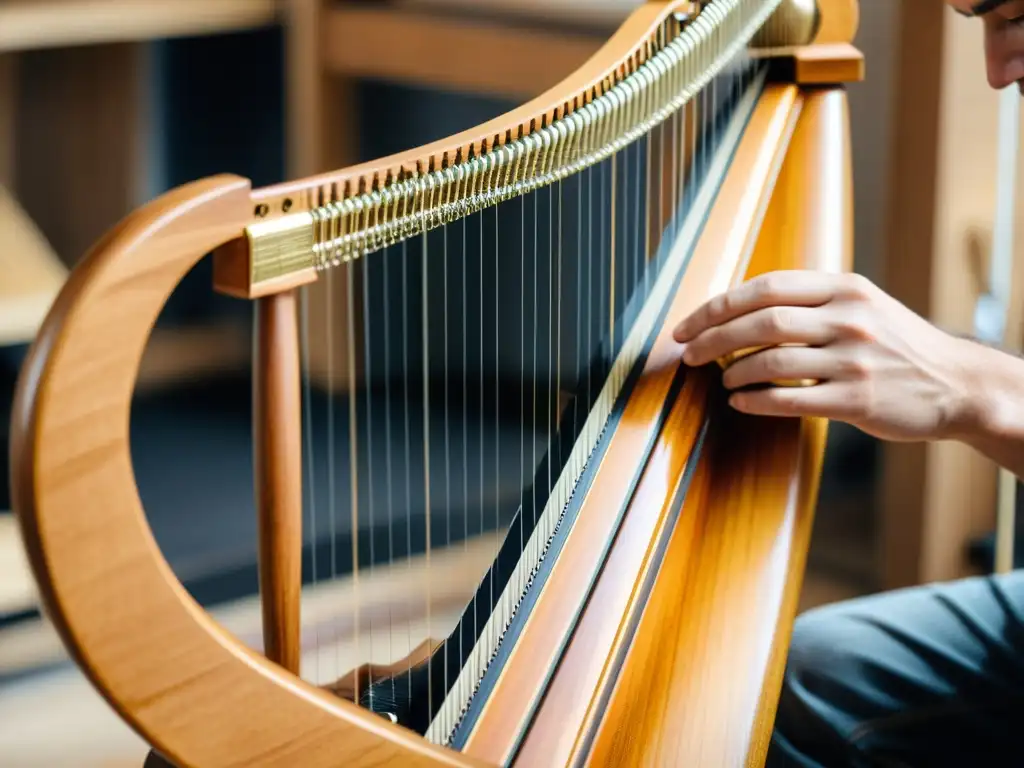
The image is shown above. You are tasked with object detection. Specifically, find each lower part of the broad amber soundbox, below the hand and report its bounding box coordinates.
[587,403,824,767]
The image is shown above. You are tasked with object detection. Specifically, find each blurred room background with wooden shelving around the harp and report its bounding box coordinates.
[0,0,1024,766]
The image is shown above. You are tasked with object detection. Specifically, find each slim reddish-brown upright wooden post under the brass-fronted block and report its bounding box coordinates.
[253,291,302,675]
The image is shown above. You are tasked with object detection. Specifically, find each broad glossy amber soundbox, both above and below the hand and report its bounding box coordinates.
[588,89,852,766]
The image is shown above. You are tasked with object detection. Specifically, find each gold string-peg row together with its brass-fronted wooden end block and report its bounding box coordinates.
[222,0,798,298]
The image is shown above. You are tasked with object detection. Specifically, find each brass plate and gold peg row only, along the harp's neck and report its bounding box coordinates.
[239,0,792,294]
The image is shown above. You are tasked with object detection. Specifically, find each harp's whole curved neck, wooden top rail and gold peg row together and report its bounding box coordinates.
[215,0,859,298]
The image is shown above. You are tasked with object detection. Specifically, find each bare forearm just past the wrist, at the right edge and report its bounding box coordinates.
[962,348,1024,478]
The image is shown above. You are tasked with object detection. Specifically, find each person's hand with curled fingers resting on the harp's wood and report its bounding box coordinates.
[673,271,985,440]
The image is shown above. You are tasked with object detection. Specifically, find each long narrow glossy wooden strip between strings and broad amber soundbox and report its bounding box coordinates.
[464,86,799,765]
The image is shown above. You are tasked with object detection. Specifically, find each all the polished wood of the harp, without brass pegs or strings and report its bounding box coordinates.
[11,0,852,768]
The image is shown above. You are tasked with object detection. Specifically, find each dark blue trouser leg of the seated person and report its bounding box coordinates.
[767,571,1024,768]
